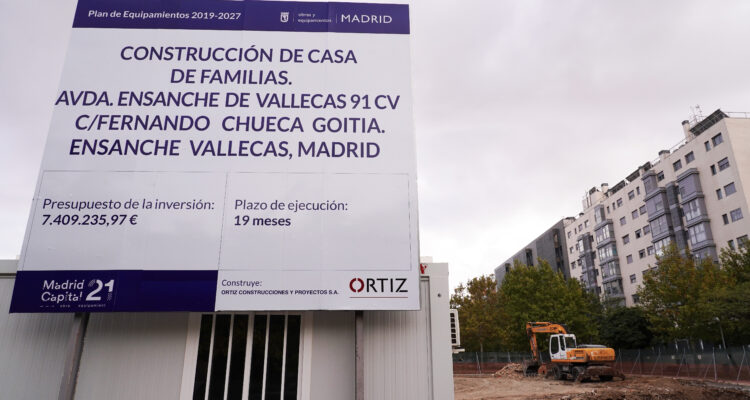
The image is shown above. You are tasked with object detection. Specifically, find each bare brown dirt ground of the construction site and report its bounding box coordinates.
[453,365,750,400]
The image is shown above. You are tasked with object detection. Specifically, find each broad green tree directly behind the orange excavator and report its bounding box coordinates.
[500,259,601,350]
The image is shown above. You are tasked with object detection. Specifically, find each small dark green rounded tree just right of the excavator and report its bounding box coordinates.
[599,307,653,349]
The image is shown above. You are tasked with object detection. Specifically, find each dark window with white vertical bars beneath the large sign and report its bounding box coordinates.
[193,313,301,399]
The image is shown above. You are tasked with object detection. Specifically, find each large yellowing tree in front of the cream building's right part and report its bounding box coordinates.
[638,244,730,340]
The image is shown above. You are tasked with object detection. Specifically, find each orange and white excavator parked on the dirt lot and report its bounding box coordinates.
[524,322,625,382]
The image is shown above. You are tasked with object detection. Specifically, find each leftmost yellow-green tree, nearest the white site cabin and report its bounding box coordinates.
[451,275,501,351]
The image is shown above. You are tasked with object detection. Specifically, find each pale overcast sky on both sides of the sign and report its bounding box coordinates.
[0,0,750,287]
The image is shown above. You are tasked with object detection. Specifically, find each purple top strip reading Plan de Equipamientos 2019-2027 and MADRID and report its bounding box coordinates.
[73,0,409,34]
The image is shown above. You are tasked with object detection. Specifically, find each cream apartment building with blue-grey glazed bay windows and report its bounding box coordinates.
[500,110,750,306]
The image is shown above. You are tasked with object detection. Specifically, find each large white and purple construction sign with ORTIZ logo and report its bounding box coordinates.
[11,0,419,312]
